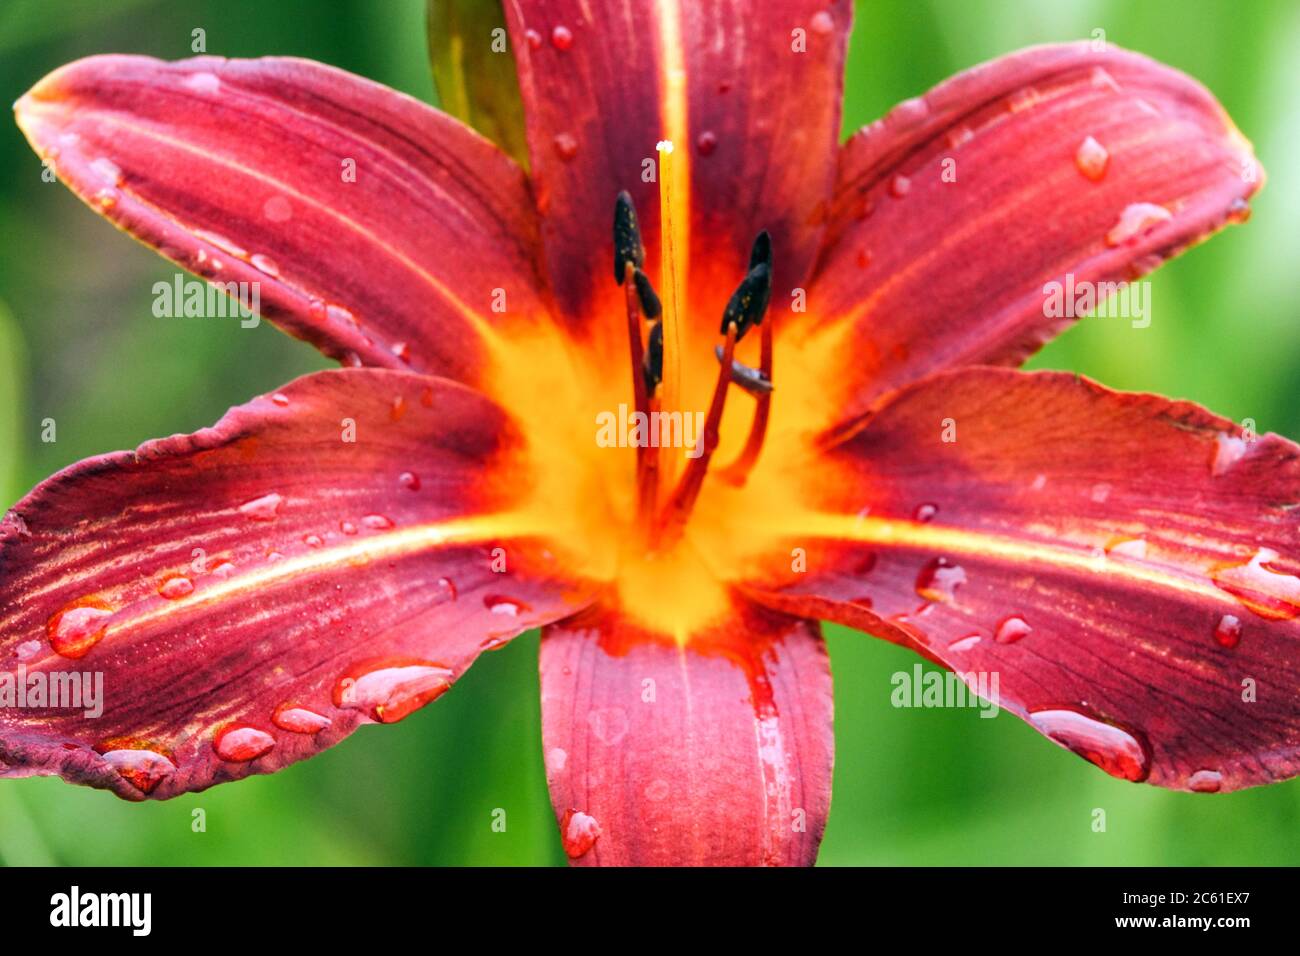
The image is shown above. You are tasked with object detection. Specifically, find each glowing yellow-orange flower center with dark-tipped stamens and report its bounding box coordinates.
[488,162,842,641]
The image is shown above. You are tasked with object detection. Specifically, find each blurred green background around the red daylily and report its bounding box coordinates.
[0,0,1300,865]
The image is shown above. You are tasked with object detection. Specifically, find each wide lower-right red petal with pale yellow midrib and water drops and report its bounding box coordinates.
[755,368,1300,790]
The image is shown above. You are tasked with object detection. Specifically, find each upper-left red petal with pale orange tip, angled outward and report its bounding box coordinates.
[16,56,545,382]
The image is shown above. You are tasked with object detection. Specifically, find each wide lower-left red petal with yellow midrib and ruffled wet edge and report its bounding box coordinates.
[0,369,595,799]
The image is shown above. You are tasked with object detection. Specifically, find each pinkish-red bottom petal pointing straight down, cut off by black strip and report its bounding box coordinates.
[542,606,833,866]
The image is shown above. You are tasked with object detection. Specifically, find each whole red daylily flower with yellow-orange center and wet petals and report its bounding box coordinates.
[0,0,1300,864]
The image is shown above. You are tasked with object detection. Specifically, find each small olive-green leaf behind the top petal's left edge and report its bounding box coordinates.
[425,0,528,168]
